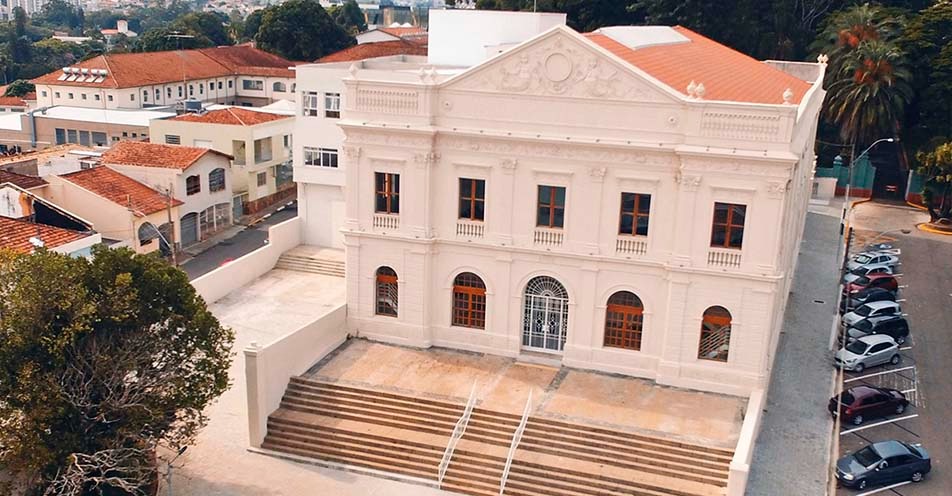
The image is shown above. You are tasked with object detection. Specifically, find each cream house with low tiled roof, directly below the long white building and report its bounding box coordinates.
[150,106,296,215]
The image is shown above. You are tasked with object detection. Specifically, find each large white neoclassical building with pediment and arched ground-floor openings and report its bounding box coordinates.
[296,11,825,395]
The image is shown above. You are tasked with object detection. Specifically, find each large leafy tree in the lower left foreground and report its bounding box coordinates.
[0,248,234,496]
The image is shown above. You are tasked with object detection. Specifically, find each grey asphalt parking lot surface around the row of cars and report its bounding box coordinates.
[824,232,952,496]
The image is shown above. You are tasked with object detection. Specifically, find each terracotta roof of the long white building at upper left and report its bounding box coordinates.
[33,45,294,88]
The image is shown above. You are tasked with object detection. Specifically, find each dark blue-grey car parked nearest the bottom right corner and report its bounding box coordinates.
[836,440,932,489]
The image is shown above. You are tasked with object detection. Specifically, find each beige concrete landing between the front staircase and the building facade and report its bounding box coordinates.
[306,339,747,449]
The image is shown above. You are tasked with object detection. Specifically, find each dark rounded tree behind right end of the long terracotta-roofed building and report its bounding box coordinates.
[255,0,354,60]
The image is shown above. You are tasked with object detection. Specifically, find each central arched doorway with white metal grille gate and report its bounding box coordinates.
[522,276,569,353]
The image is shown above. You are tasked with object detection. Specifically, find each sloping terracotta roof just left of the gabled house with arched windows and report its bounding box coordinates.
[60,166,182,216]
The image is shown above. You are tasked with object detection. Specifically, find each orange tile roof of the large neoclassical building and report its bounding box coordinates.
[584,26,810,104]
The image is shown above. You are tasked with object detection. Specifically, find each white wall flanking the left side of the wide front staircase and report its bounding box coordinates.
[245,304,347,448]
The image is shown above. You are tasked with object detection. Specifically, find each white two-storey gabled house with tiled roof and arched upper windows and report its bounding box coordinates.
[99,141,234,248]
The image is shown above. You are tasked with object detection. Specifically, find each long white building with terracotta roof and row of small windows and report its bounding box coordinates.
[33,44,295,109]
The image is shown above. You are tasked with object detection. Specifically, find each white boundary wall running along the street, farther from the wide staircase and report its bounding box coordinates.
[192,217,301,305]
